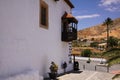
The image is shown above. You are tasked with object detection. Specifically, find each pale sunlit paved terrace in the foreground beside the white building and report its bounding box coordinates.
[58,71,115,80]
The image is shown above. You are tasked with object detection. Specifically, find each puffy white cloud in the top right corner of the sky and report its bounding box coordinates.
[99,0,120,11]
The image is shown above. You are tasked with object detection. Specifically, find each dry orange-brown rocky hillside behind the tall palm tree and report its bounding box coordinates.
[78,18,120,39]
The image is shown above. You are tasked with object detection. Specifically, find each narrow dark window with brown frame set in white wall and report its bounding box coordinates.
[40,0,48,29]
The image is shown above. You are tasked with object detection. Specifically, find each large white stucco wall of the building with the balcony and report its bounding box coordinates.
[0,0,71,76]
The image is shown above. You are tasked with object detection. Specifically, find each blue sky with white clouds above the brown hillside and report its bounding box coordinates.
[70,0,120,30]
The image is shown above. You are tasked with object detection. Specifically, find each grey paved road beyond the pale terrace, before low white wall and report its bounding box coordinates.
[76,59,120,73]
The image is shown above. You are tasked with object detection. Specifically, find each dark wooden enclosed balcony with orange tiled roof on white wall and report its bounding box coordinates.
[62,12,78,42]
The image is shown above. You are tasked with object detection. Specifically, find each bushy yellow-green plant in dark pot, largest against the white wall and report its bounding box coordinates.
[49,62,58,79]
